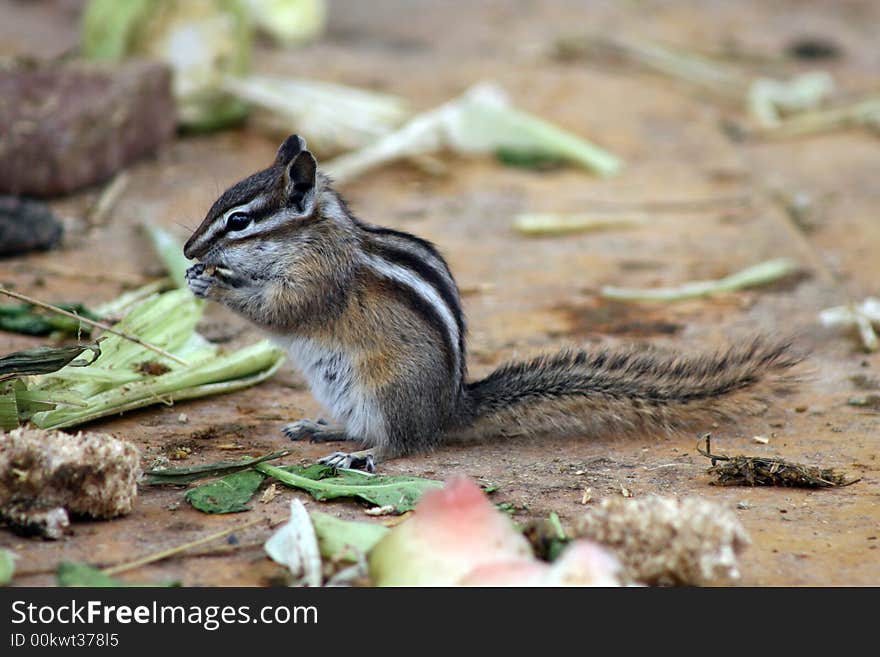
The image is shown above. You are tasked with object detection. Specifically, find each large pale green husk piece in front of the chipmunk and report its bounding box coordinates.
[0,223,284,429]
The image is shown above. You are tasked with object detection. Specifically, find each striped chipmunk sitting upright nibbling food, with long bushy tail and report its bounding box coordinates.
[184,135,799,471]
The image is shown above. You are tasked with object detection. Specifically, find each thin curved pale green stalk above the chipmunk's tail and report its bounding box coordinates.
[599,258,800,301]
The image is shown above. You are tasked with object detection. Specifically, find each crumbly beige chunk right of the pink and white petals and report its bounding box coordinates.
[572,495,749,586]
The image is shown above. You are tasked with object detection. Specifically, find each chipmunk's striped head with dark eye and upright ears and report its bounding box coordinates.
[183,135,318,265]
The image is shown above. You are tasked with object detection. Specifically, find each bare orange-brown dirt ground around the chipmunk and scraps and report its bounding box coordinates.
[0,0,880,586]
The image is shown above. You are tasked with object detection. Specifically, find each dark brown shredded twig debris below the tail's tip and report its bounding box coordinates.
[697,434,861,488]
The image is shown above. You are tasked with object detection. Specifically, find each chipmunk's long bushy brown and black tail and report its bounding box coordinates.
[465,338,802,436]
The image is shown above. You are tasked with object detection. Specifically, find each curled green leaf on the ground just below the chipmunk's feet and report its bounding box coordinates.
[256,463,443,513]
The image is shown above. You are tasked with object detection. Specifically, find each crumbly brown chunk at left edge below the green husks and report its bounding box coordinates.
[0,428,140,538]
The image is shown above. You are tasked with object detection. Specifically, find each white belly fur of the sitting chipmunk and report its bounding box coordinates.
[273,336,386,446]
